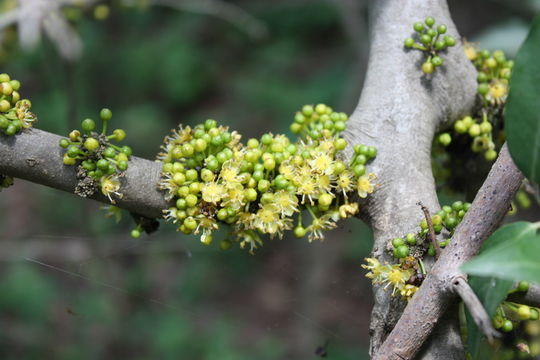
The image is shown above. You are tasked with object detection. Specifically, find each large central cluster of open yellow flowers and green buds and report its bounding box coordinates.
[158,104,377,252]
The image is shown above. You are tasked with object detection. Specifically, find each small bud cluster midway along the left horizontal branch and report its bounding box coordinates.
[60,109,132,204]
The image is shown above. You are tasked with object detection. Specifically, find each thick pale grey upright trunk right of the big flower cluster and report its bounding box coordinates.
[345,0,476,359]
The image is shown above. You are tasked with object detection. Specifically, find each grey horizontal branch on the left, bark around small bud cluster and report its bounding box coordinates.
[0,129,170,218]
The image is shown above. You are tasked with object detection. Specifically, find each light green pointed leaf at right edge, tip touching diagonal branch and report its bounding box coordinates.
[461,222,540,283]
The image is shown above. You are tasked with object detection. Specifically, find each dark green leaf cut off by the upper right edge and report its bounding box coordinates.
[505,15,540,182]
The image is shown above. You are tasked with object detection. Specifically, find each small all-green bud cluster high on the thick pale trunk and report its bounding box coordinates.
[404,16,456,74]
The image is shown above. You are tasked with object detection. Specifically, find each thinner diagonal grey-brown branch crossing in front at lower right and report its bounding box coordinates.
[373,145,523,360]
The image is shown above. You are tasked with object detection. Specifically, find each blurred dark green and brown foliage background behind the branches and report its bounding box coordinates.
[0,0,540,360]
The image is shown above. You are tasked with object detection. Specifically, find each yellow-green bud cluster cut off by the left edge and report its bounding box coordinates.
[0,74,37,136]
